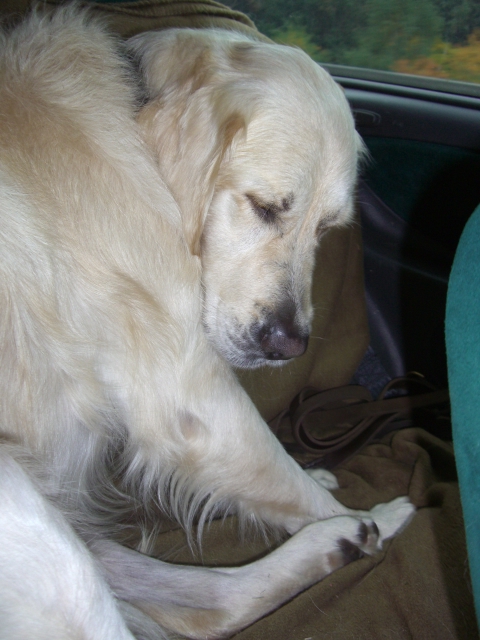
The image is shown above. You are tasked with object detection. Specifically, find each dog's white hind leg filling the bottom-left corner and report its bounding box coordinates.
[0,445,133,640]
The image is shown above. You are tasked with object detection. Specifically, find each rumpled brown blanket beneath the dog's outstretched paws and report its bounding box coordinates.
[152,429,478,640]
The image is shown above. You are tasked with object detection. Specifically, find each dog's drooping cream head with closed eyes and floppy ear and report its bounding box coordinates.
[131,30,362,368]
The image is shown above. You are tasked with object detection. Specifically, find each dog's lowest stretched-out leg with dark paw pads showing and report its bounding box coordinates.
[93,516,379,639]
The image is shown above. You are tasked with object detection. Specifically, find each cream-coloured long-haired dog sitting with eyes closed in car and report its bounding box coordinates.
[0,9,413,640]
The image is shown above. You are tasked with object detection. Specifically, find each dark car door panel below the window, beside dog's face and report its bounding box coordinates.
[336,77,480,386]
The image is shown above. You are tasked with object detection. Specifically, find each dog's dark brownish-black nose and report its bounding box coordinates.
[260,319,308,360]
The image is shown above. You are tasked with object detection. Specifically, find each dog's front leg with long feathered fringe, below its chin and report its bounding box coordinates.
[117,331,413,539]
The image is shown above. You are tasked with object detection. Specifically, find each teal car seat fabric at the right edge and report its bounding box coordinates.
[445,206,480,619]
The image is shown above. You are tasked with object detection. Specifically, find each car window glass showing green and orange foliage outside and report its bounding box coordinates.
[224,0,480,83]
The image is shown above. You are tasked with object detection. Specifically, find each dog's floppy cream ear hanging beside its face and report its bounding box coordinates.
[134,30,248,255]
